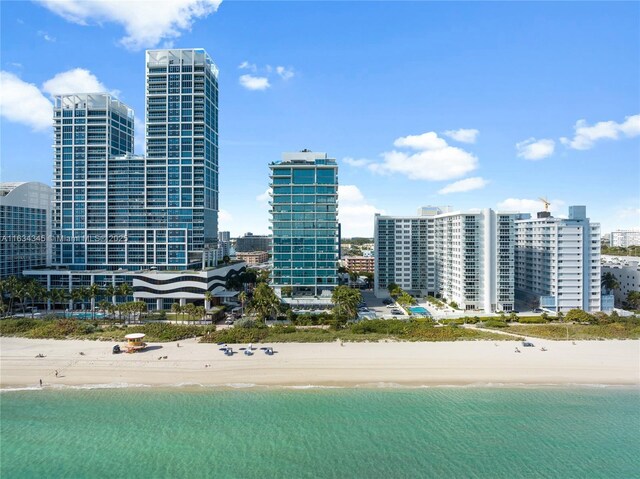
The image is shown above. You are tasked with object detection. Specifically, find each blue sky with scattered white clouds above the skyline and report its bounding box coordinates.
[0,0,640,236]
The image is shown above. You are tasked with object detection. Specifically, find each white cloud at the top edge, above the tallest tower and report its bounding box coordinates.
[39,0,222,50]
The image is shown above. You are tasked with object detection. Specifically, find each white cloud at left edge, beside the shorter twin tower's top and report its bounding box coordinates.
[0,71,53,131]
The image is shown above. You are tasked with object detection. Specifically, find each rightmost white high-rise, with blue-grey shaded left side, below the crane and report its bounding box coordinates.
[515,206,601,312]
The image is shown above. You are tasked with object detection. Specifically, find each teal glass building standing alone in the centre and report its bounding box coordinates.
[269,150,338,297]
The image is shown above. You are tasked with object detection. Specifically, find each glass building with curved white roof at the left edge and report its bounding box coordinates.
[0,182,53,279]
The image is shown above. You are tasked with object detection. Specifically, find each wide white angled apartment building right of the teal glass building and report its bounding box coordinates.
[374,207,516,312]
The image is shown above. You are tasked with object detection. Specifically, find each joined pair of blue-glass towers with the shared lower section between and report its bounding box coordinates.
[25,49,244,307]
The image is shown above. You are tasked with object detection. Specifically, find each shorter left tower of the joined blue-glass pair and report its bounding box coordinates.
[52,93,134,269]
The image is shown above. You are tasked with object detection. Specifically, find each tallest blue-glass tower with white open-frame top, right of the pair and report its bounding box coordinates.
[145,49,218,269]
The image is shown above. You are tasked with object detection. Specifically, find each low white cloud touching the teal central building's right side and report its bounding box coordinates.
[338,185,384,238]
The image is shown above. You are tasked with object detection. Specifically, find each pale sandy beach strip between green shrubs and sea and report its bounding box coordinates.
[0,337,640,389]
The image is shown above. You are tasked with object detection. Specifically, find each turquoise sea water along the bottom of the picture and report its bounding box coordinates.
[0,388,640,479]
